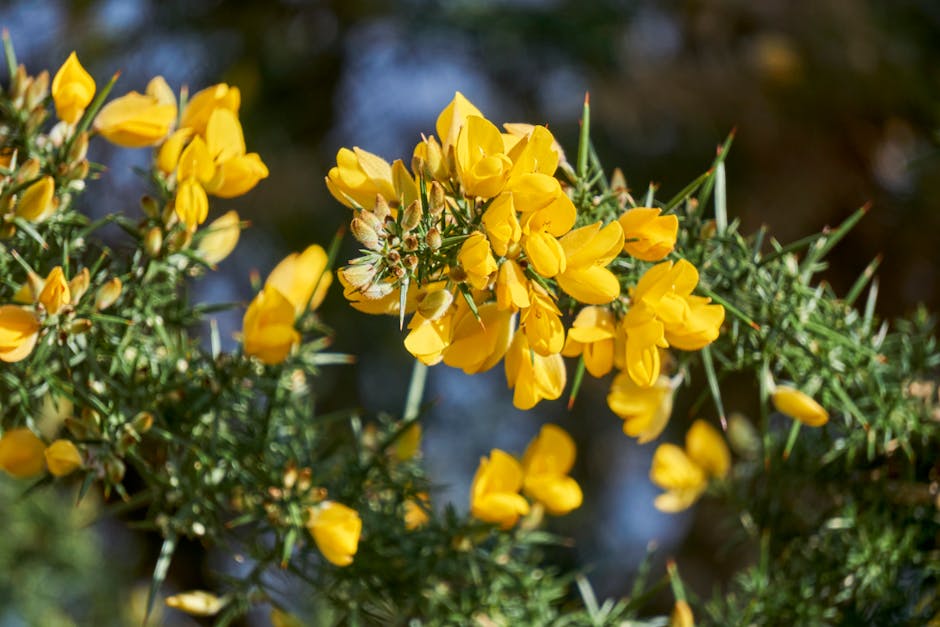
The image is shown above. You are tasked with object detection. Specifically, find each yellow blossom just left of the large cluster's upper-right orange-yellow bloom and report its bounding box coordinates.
[558,222,623,305]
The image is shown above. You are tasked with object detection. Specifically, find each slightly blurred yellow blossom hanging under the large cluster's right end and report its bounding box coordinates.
[607,372,672,444]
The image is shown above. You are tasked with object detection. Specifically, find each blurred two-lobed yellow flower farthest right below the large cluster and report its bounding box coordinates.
[650,420,731,512]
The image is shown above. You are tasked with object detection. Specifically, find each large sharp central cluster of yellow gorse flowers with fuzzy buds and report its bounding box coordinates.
[326,92,724,424]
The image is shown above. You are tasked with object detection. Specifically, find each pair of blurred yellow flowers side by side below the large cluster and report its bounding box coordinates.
[470,424,582,529]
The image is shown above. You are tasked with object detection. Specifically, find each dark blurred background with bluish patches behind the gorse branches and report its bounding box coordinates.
[0,0,940,627]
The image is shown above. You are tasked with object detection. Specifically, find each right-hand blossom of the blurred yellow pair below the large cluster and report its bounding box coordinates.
[522,425,582,516]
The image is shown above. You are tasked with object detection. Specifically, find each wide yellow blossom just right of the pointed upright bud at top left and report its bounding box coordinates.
[93,76,176,148]
